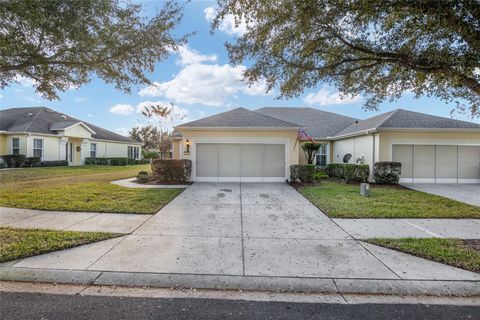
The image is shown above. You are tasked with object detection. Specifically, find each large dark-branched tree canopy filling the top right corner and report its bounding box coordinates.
[212,0,480,116]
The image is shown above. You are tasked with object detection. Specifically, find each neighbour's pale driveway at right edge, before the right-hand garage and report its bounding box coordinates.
[402,183,480,206]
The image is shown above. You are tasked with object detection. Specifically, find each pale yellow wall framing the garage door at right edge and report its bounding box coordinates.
[379,131,480,161]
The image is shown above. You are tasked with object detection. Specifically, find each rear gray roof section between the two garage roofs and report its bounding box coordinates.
[255,107,357,140]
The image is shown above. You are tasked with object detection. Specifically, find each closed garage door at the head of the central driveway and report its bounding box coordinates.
[195,143,286,182]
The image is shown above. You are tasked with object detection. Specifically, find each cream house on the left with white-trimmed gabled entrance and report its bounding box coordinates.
[0,107,142,166]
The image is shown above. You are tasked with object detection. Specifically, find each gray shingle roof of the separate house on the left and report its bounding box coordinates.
[0,107,142,143]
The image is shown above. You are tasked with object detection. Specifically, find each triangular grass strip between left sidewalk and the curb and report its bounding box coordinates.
[0,228,120,262]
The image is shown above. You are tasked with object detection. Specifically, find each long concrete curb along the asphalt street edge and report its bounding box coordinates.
[0,267,480,297]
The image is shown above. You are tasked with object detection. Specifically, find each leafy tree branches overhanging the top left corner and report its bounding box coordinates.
[0,0,186,100]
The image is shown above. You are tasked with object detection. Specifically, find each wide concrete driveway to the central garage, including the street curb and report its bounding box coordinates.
[0,183,480,294]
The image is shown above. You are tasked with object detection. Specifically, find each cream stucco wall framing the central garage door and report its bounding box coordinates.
[179,129,299,165]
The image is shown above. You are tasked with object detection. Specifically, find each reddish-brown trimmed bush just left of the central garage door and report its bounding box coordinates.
[152,159,192,183]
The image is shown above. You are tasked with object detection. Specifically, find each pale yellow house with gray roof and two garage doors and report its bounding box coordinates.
[173,107,480,183]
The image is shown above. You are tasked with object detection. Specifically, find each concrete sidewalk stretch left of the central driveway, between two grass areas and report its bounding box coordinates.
[0,207,152,233]
